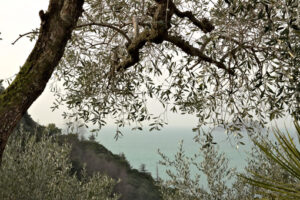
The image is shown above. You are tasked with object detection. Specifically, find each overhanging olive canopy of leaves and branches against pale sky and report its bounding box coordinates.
[45,0,300,136]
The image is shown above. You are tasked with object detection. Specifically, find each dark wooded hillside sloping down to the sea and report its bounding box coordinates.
[15,113,161,200]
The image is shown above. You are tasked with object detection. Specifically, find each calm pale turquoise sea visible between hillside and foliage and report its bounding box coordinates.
[96,127,251,179]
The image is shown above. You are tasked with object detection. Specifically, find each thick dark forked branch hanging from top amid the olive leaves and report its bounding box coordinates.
[111,0,226,75]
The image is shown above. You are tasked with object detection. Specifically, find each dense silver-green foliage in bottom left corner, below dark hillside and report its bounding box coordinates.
[0,133,118,200]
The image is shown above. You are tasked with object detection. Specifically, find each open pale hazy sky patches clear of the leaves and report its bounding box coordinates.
[0,0,197,128]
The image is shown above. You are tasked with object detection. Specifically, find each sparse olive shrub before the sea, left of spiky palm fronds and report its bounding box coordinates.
[160,138,238,200]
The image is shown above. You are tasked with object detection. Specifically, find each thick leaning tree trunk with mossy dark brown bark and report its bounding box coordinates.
[0,0,84,165]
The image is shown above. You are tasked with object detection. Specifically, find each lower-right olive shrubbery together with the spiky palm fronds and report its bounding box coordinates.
[159,125,300,200]
